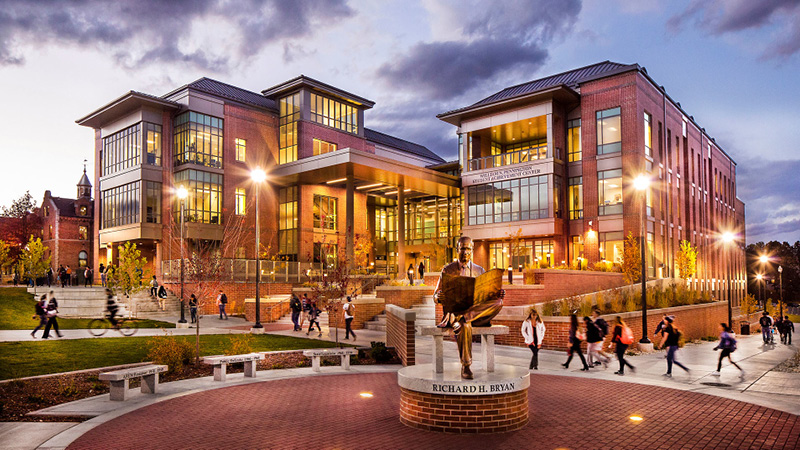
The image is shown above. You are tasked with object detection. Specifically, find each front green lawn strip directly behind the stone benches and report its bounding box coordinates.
[0,334,336,380]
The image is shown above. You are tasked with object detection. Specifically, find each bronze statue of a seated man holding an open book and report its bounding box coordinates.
[433,236,505,380]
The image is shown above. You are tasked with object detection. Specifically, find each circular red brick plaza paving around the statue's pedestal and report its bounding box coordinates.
[69,373,800,450]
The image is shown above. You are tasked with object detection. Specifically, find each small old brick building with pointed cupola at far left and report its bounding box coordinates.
[39,169,95,282]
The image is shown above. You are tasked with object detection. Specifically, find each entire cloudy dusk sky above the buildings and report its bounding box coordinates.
[0,0,800,242]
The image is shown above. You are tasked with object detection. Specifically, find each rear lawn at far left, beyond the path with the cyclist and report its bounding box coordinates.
[0,288,175,330]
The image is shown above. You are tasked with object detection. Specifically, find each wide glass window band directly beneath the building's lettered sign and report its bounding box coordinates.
[467,175,550,225]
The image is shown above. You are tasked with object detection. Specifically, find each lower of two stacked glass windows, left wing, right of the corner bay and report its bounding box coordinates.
[175,169,222,224]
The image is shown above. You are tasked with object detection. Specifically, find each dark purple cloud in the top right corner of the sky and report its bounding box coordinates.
[667,0,800,58]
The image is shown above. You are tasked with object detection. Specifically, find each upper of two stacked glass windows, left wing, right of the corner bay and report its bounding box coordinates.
[173,111,223,169]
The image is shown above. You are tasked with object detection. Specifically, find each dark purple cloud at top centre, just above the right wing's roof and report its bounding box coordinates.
[376,0,581,99]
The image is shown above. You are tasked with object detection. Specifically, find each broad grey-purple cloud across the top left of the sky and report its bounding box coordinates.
[0,0,354,72]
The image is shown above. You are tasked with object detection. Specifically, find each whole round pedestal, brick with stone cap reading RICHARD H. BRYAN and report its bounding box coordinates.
[397,363,530,434]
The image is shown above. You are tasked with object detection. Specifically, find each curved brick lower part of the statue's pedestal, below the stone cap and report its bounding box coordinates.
[400,388,528,434]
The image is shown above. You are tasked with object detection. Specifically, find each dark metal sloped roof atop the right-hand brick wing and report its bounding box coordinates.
[438,61,639,117]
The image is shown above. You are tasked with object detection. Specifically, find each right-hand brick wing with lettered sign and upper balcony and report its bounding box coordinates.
[438,61,745,299]
